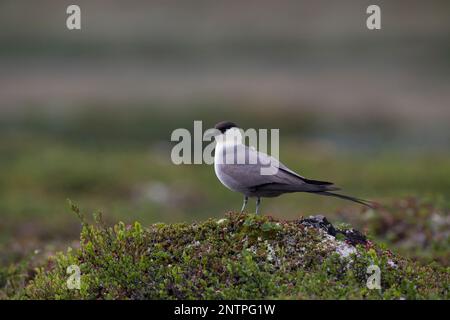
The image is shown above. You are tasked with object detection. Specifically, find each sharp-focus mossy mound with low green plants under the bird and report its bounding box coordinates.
[22,208,450,299]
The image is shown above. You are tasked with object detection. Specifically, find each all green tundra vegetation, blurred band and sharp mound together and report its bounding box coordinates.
[0,108,450,299]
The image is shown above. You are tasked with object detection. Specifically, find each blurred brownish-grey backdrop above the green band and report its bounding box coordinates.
[0,0,450,127]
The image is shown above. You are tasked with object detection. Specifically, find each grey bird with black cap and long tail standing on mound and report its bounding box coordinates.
[212,121,373,214]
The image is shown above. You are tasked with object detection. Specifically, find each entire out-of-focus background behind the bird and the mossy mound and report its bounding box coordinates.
[0,0,450,280]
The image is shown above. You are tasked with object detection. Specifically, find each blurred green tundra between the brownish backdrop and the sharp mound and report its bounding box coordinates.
[0,103,450,300]
